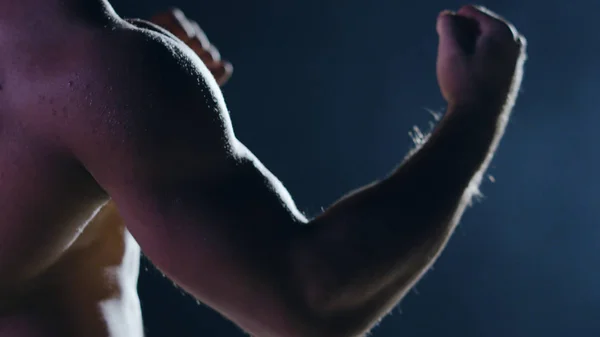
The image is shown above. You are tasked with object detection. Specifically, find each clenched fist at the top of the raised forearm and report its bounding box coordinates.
[437,6,526,106]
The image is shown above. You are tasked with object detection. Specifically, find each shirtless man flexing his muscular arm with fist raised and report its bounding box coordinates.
[0,0,525,337]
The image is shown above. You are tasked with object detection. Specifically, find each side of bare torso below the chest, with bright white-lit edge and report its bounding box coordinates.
[0,205,143,337]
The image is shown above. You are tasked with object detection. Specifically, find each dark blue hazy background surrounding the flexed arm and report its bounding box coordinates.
[114,0,600,337]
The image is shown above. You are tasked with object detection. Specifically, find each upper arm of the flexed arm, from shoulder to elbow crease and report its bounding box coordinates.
[58,28,318,334]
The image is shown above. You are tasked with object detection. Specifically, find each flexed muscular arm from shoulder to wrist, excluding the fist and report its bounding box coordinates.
[57,14,514,337]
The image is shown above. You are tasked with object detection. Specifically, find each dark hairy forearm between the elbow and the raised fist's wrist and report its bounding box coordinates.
[292,99,512,335]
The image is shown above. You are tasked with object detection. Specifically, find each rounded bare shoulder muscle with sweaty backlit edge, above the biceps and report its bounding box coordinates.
[57,22,233,186]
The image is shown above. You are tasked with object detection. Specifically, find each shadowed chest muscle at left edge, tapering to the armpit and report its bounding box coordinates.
[0,127,105,287]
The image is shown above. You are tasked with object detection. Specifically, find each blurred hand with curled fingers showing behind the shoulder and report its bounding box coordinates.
[134,8,233,86]
